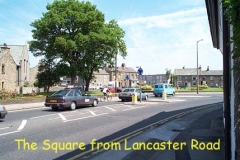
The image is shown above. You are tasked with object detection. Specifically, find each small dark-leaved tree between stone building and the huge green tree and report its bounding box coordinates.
[34,59,60,92]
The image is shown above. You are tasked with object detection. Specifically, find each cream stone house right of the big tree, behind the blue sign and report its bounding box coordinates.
[105,63,139,87]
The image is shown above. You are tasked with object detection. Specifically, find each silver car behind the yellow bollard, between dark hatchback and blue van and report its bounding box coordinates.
[118,88,148,101]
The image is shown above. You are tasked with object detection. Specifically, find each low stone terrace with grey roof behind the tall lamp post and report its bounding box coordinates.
[174,67,223,87]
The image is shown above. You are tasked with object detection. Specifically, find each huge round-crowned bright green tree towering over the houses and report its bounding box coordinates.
[29,0,127,90]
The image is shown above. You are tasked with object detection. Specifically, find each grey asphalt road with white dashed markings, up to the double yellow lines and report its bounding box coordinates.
[0,93,223,160]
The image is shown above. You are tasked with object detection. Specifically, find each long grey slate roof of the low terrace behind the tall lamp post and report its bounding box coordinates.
[174,68,223,76]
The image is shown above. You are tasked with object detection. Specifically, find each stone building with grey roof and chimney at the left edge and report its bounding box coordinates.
[0,43,30,93]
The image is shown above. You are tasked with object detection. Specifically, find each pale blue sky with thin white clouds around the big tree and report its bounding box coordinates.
[0,0,222,74]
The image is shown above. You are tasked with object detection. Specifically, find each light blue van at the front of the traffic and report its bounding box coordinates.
[153,83,175,97]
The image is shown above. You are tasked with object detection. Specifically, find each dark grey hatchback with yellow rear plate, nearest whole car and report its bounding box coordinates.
[44,88,98,110]
